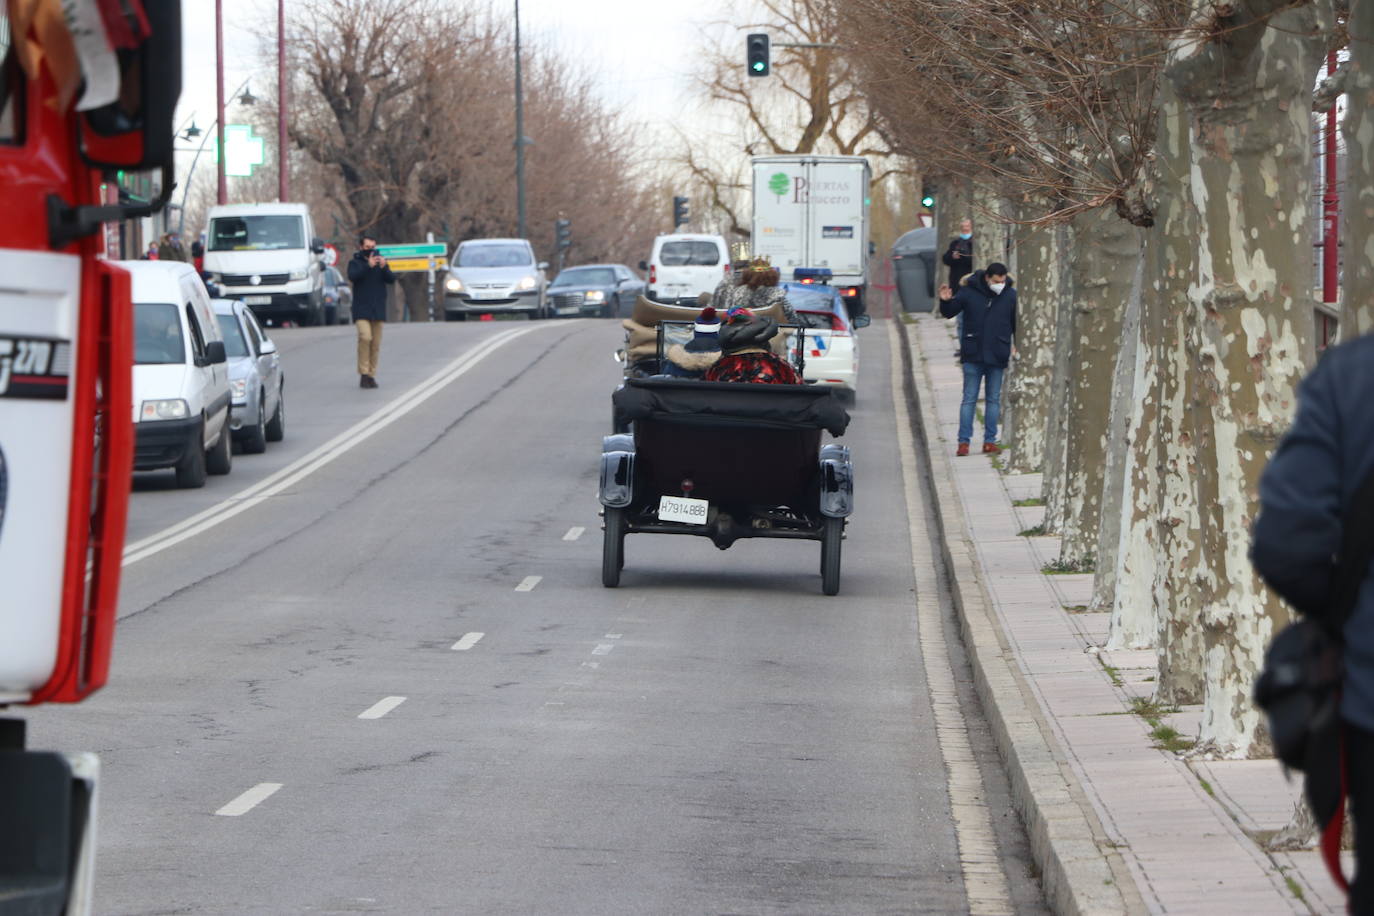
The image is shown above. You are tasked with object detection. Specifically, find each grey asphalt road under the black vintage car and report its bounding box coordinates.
[30,320,1043,913]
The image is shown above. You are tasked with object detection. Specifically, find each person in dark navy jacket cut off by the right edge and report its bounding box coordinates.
[1250,335,1374,916]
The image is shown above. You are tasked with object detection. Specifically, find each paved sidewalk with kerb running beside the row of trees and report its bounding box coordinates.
[901,316,1344,915]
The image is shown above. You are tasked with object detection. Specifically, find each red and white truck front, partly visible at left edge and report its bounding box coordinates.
[0,0,181,916]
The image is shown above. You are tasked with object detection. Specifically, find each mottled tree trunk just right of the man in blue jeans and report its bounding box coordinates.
[1006,216,1065,474]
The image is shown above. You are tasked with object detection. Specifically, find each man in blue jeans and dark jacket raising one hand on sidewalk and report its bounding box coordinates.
[940,262,1017,455]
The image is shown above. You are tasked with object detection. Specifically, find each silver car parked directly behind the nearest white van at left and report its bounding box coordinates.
[212,299,286,455]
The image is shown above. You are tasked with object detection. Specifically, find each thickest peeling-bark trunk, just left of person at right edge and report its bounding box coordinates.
[1165,0,1333,757]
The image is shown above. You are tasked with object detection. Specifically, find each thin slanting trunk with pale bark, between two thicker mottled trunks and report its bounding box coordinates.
[1091,229,1146,611]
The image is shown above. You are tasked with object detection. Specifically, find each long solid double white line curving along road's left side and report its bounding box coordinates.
[124,321,552,566]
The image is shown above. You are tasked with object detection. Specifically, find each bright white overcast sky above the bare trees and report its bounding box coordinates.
[177,0,745,193]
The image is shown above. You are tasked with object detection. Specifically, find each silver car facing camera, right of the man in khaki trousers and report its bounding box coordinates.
[444,239,548,321]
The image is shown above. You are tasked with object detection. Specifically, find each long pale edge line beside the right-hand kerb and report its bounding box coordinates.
[888,321,1013,916]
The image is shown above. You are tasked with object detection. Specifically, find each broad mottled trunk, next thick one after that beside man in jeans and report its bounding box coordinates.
[1059,207,1139,567]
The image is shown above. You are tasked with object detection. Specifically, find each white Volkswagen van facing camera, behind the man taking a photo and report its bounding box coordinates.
[205,203,326,324]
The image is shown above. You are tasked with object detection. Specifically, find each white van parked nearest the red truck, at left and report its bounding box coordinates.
[118,261,232,488]
